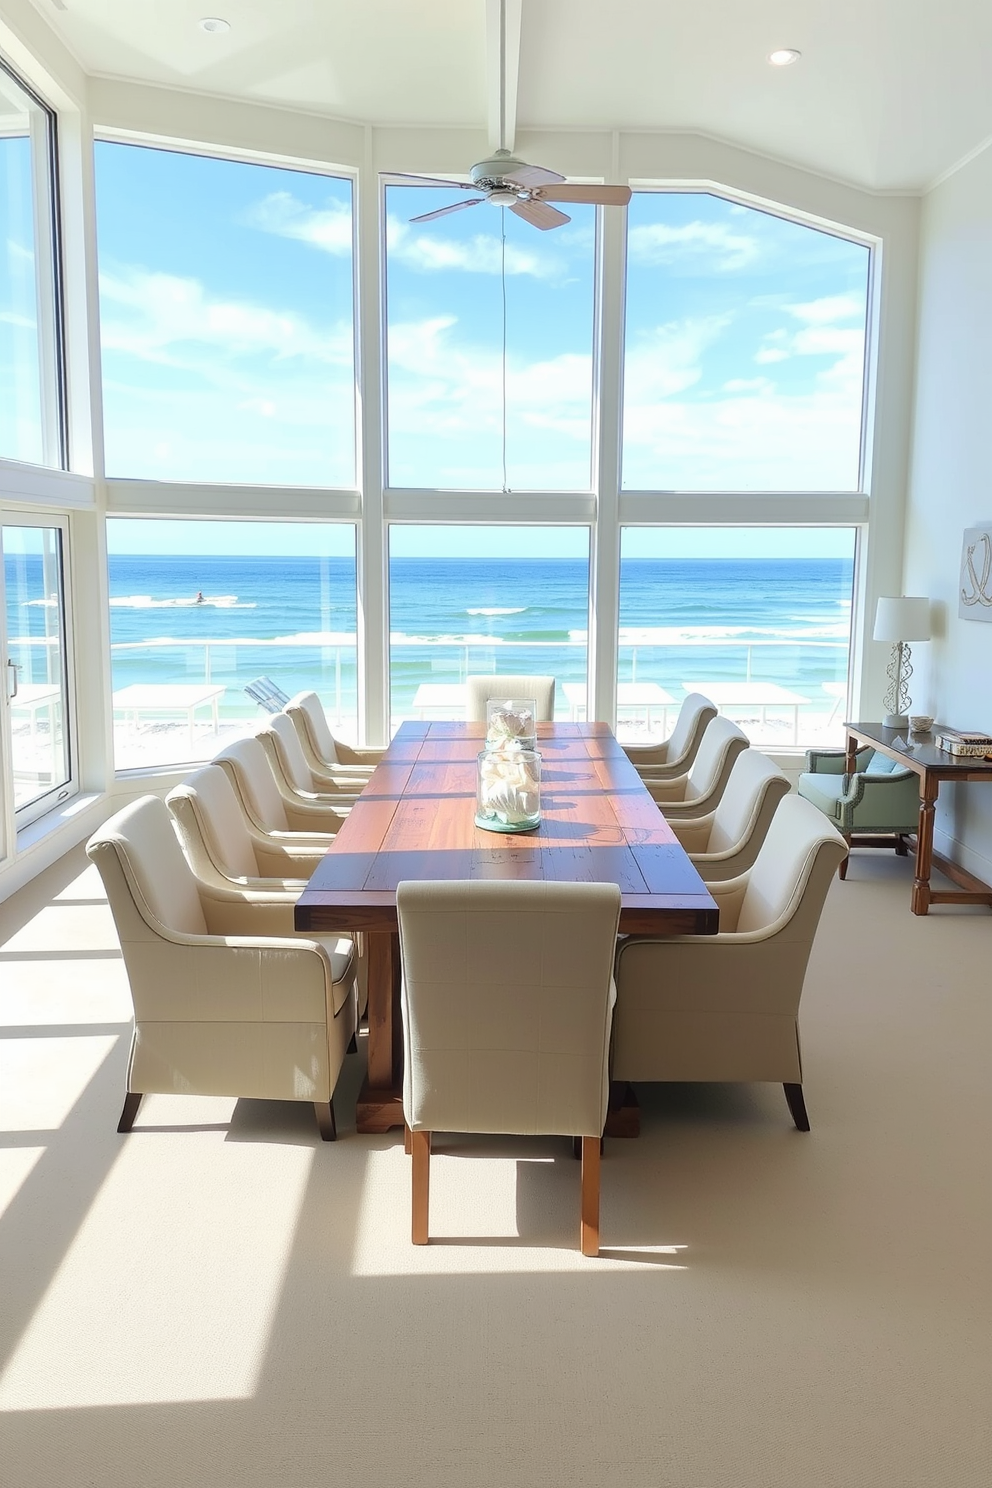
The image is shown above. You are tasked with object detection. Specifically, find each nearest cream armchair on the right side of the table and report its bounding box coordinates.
[613,796,848,1131]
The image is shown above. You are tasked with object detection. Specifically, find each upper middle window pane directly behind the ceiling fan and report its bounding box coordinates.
[385,186,595,491]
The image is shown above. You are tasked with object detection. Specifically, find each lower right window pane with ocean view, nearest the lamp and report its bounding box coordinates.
[617,527,855,748]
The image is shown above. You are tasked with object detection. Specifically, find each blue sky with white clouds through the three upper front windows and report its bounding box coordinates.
[97,141,869,552]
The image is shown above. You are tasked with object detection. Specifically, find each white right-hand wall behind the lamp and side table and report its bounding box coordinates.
[903,149,992,882]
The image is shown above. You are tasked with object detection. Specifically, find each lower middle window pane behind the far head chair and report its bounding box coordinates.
[390,525,589,729]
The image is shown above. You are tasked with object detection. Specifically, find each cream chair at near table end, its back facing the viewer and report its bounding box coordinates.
[396,879,620,1256]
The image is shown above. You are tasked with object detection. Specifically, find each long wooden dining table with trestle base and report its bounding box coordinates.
[296,722,718,1132]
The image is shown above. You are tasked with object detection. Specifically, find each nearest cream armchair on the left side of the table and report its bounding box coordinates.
[86,796,355,1141]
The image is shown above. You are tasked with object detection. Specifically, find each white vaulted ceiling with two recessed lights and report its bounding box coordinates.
[21,0,992,192]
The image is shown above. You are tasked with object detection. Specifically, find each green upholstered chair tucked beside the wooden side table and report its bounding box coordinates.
[797,748,919,878]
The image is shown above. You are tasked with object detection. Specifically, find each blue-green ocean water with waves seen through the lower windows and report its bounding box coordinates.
[9,555,852,717]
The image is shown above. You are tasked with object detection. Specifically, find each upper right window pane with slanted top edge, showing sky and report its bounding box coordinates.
[623,190,870,491]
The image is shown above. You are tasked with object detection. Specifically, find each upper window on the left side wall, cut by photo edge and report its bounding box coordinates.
[0,61,65,466]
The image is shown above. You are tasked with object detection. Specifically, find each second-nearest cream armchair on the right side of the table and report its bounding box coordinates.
[668,748,790,884]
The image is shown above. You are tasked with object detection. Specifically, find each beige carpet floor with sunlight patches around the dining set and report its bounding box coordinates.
[0,853,992,1488]
